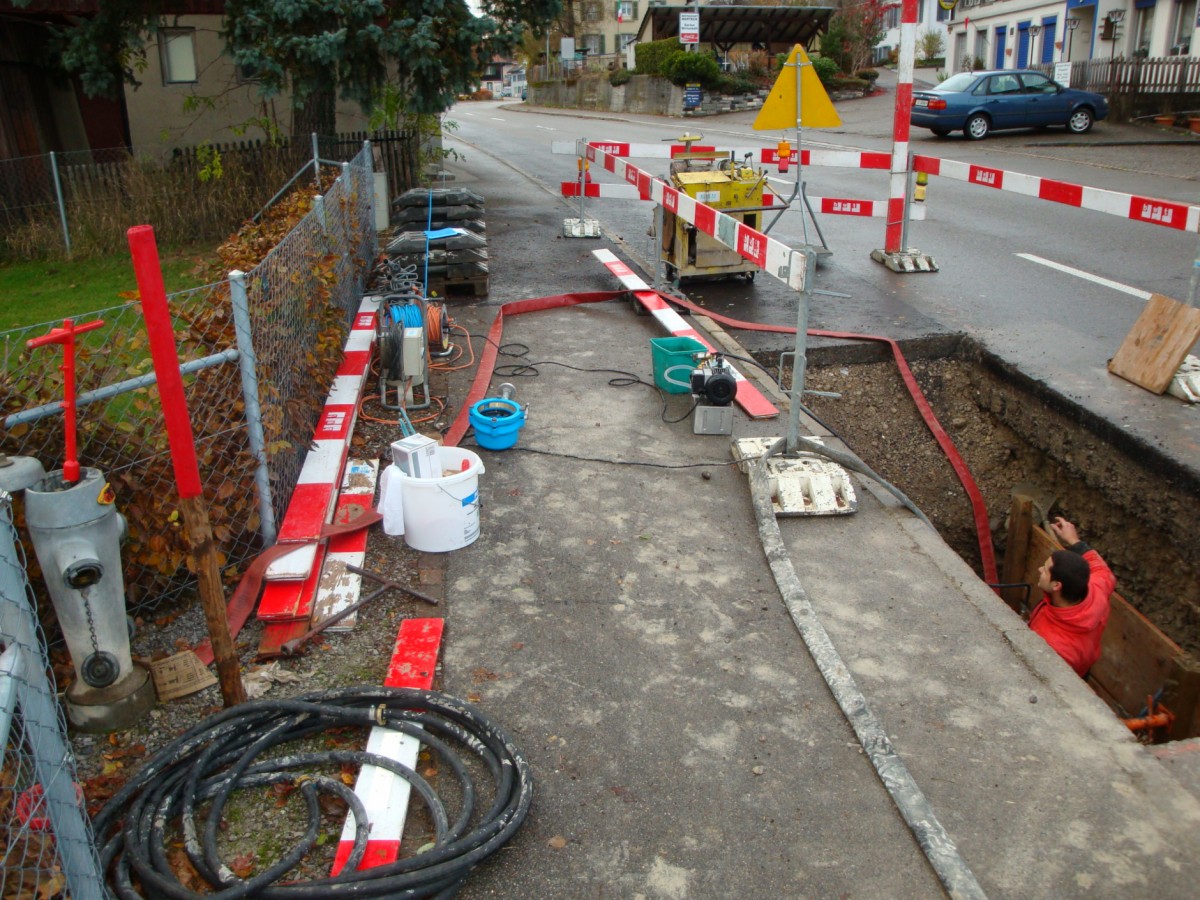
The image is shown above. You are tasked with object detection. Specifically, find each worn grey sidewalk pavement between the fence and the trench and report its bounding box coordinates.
[398,144,1200,899]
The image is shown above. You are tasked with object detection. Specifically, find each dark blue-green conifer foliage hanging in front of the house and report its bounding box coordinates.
[17,0,560,133]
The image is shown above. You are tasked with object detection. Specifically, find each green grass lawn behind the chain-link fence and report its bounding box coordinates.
[0,247,211,331]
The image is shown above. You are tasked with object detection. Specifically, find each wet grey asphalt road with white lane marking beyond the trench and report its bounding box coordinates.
[448,79,1200,460]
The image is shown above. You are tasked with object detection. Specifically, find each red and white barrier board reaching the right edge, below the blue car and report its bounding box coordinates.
[912,156,1200,233]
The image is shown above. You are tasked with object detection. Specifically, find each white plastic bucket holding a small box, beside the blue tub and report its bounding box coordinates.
[392,446,484,553]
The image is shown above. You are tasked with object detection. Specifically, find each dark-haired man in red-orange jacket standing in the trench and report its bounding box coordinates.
[1030,516,1117,678]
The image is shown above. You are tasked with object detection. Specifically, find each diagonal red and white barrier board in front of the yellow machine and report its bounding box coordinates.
[580,140,805,290]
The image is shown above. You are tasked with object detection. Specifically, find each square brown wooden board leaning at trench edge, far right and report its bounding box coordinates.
[1109,294,1200,394]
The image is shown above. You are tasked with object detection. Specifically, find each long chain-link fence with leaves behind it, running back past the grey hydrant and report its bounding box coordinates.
[0,145,376,628]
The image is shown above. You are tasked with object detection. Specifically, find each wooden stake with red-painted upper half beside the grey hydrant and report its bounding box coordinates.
[126,226,246,707]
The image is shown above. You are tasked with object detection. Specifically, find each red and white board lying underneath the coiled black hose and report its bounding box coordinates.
[330,619,445,876]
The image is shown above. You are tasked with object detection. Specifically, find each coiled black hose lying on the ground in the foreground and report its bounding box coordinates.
[94,686,533,900]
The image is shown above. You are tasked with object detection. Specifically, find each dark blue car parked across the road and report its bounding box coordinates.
[910,68,1109,140]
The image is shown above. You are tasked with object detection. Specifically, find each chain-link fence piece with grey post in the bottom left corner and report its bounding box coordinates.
[0,491,104,900]
